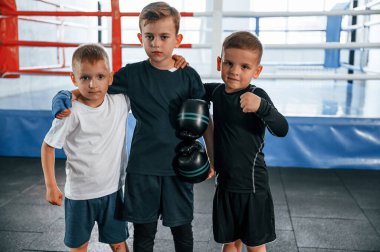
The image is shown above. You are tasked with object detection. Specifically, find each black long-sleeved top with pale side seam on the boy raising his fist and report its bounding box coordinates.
[205,83,288,192]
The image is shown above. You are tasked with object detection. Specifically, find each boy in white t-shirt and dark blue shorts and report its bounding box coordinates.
[41,44,130,251]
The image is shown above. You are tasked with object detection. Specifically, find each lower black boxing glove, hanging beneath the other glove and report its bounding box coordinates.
[173,140,210,184]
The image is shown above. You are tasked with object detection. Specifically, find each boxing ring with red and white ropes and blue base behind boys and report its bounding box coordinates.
[0,0,380,170]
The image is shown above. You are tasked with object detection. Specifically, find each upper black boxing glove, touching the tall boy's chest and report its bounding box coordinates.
[177,99,209,140]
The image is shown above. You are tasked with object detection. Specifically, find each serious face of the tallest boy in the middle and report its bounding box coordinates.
[137,17,182,69]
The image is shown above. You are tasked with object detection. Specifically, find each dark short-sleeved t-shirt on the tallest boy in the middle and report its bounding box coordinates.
[109,60,205,176]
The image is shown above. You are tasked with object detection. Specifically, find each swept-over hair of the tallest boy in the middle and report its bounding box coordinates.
[139,2,181,34]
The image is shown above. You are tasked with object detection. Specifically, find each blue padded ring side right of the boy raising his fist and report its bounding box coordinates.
[264,117,380,170]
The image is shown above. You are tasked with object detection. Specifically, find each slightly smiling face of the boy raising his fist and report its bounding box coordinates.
[217,48,262,93]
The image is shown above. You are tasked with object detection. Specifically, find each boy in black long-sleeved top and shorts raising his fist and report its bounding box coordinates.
[205,32,288,252]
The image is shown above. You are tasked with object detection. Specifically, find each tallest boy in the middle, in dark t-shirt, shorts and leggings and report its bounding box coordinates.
[51,2,213,252]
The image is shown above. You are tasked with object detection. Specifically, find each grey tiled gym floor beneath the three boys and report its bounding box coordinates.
[0,157,380,252]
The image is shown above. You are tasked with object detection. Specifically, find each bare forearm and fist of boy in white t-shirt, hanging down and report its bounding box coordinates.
[41,142,63,206]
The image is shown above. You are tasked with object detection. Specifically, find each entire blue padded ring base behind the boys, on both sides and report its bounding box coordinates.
[0,110,380,170]
